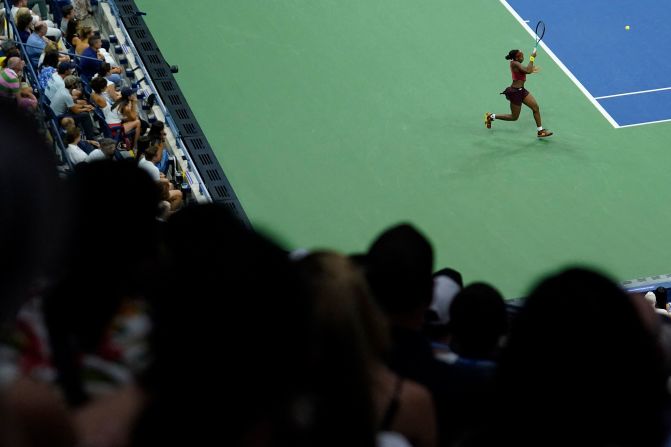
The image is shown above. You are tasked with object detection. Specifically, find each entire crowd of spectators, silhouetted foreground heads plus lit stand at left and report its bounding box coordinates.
[0,0,671,447]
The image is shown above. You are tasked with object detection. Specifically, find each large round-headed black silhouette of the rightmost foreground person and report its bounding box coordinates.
[464,269,668,447]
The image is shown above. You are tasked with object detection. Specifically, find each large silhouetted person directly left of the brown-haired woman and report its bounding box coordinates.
[130,204,368,447]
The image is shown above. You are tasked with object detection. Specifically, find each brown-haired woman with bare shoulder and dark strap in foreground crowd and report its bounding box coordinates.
[297,252,437,447]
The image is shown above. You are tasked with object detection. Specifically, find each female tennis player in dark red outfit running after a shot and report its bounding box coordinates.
[485,50,552,138]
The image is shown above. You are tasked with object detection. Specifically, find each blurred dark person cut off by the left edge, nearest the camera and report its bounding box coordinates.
[0,104,76,447]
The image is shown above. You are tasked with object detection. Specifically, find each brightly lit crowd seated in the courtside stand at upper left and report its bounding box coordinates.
[0,0,184,212]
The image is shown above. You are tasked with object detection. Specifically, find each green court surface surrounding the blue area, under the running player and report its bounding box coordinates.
[136,0,671,298]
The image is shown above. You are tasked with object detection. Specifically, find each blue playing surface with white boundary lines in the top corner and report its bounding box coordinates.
[501,0,671,127]
